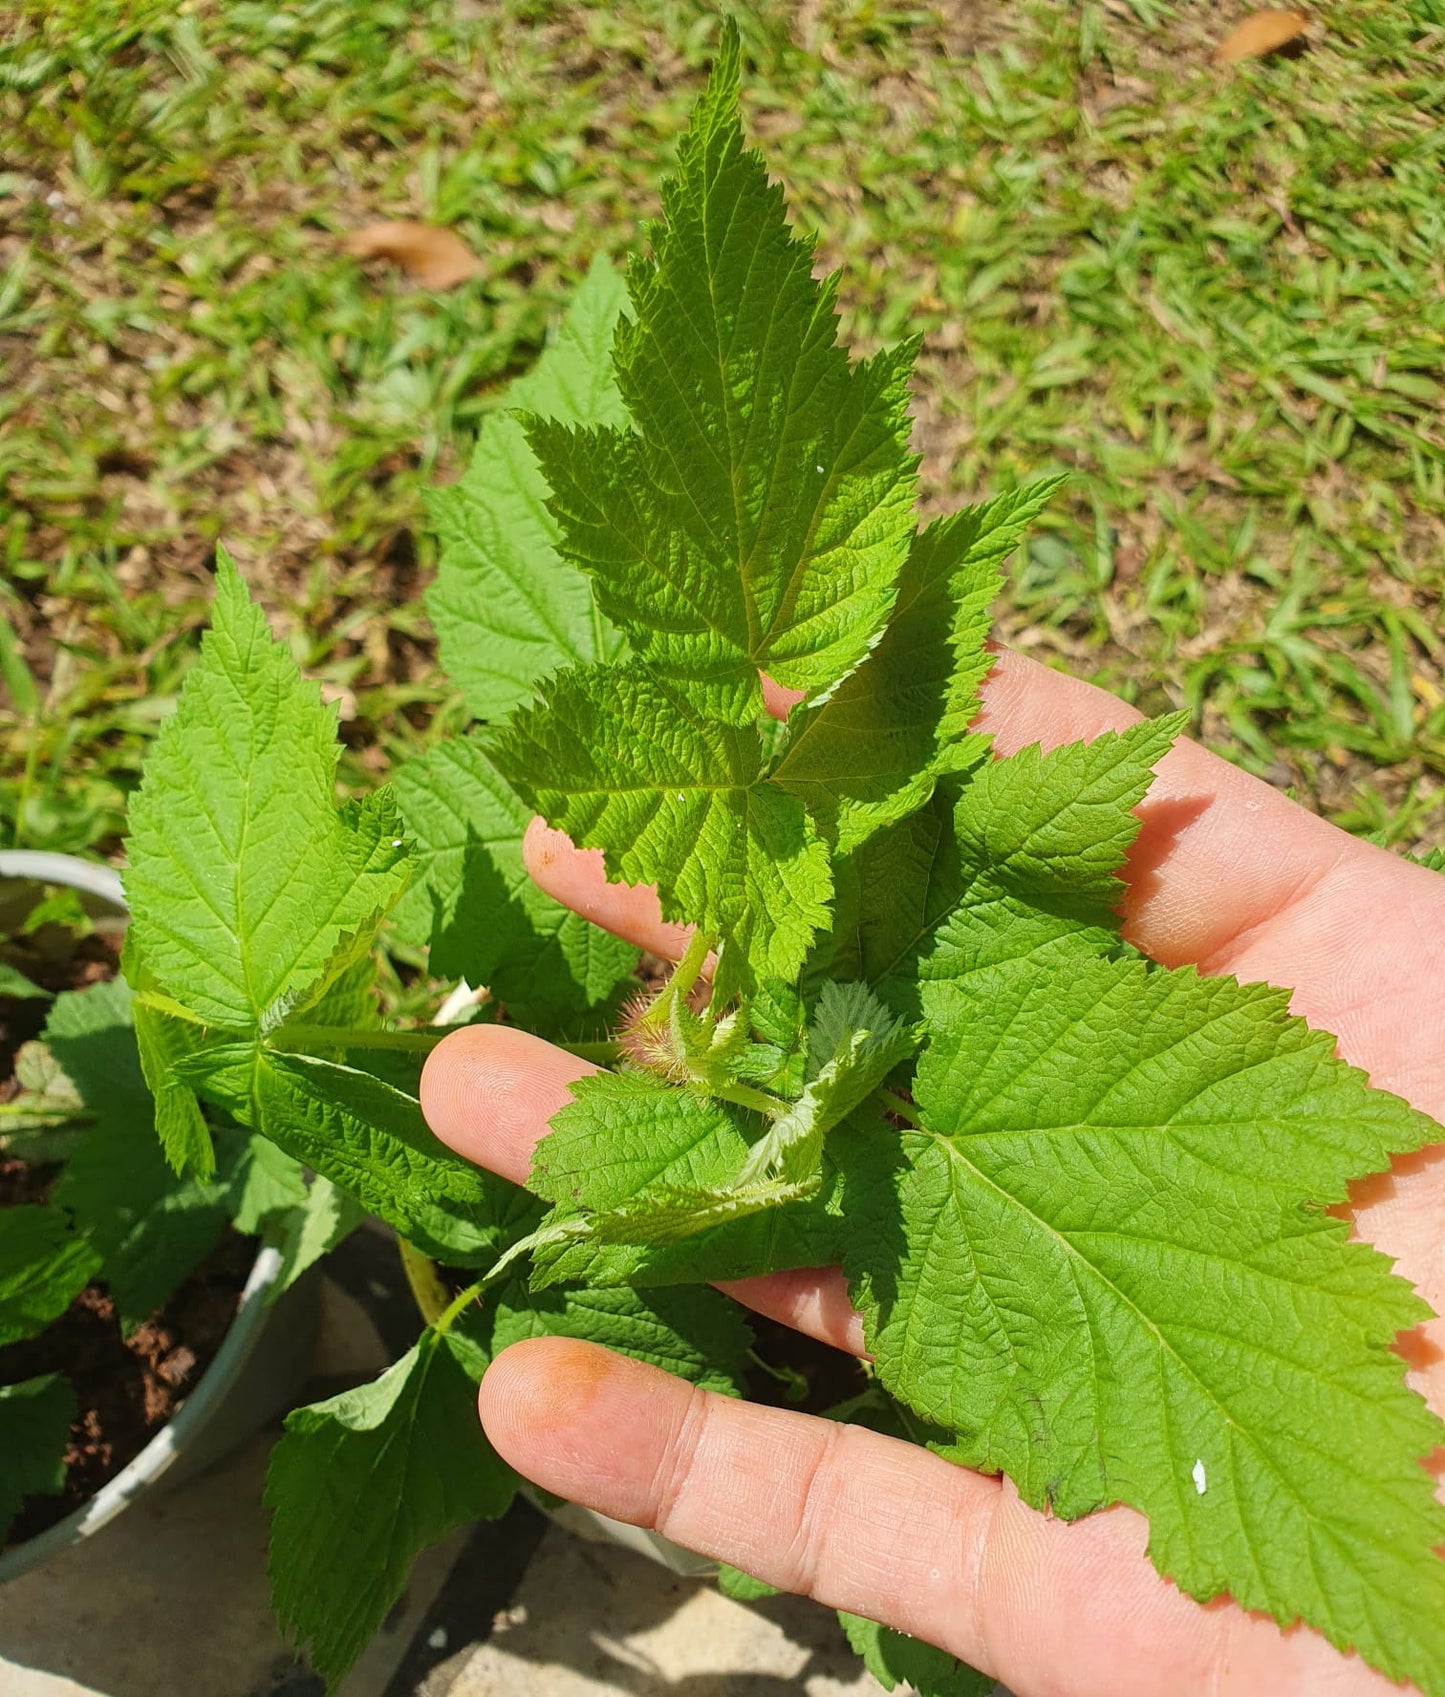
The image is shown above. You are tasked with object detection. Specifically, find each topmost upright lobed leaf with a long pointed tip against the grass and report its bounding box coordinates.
[527,27,918,720]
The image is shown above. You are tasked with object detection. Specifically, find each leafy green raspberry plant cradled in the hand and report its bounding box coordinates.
[115,29,1445,1694]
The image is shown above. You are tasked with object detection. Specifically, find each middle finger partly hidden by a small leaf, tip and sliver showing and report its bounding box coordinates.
[421,1025,863,1354]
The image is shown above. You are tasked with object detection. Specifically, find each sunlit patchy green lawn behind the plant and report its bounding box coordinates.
[0,0,1445,854]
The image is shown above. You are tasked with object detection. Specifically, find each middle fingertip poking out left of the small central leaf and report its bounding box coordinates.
[421,1025,597,1185]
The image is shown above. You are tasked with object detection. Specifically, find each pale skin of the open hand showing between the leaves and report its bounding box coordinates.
[422,653,1445,1697]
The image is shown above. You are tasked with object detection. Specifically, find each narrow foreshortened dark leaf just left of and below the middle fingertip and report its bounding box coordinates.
[178,1044,512,1266]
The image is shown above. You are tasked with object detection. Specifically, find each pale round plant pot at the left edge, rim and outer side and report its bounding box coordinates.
[0,852,317,1582]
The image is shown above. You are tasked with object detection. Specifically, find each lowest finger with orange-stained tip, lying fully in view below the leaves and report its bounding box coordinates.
[480,1339,1398,1697]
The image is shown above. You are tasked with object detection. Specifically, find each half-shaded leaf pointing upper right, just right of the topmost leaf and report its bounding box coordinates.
[773,477,1062,854]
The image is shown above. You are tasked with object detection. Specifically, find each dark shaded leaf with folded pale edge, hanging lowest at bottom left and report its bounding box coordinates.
[266,1330,516,1689]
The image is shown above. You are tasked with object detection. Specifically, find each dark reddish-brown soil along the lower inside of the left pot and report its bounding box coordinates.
[0,1235,256,1544]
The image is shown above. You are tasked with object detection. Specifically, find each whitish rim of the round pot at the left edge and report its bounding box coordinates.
[0,849,282,1583]
